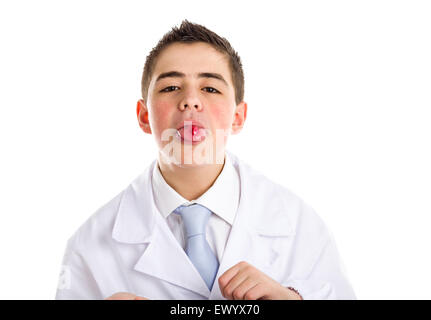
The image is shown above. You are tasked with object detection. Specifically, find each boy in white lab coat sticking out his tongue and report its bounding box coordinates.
[56,20,355,300]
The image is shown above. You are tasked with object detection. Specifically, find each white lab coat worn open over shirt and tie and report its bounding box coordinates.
[56,151,356,300]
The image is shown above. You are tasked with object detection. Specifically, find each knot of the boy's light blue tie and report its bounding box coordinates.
[174,203,212,238]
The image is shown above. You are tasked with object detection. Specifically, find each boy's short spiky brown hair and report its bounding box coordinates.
[141,20,244,104]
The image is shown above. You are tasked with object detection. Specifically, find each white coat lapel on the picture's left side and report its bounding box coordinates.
[112,161,210,298]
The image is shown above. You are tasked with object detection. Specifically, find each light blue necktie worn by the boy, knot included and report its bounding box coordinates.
[174,203,219,290]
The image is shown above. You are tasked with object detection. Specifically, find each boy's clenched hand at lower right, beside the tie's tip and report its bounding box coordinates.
[218,261,301,300]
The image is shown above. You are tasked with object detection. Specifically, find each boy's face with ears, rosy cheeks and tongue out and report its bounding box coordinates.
[137,42,247,167]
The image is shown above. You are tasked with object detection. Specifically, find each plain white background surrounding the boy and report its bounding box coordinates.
[0,0,431,299]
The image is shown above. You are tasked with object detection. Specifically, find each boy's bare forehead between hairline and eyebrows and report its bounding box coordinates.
[152,42,232,86]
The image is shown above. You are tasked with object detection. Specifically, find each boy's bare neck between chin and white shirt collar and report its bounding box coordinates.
[158,155,226,201]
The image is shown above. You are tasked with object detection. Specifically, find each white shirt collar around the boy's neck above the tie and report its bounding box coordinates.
[152,152,240,225]
